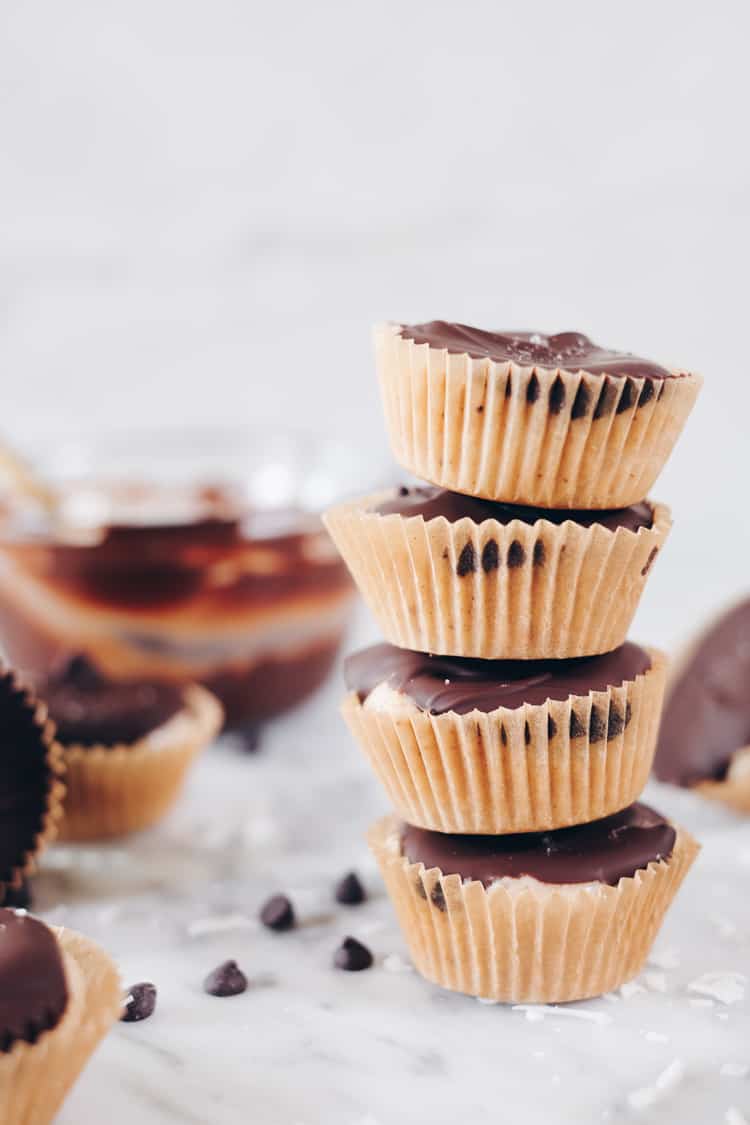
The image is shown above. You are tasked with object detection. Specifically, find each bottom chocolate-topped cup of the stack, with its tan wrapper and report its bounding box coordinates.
[369,804,698,1004]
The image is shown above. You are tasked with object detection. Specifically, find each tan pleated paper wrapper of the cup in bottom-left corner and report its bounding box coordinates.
[0,928,123,1125]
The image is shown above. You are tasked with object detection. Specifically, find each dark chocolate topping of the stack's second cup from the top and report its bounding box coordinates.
[374,485,653,531]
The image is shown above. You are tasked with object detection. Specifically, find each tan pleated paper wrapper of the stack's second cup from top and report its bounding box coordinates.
[325,492,671,660]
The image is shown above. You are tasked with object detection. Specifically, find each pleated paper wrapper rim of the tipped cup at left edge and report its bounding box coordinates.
[0,668,65,900]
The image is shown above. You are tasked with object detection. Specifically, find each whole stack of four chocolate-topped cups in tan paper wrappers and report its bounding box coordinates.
[326,322,701,1002]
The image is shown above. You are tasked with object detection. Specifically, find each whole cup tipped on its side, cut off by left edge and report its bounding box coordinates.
[0,669,64,901]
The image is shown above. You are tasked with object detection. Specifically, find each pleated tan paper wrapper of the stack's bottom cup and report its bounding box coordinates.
[369,817,698,1004]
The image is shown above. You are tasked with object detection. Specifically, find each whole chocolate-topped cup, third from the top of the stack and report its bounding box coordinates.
[342,642,666,835]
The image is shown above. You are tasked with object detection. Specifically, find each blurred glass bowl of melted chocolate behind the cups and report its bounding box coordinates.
[0,484,353,725]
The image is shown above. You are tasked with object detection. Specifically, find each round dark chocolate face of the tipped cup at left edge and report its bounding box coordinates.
[0,673,55,896]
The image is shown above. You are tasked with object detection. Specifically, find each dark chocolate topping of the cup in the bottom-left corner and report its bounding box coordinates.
[0,909,67,1052]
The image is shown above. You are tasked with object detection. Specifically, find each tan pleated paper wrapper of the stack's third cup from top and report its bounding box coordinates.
[342,649,667,835]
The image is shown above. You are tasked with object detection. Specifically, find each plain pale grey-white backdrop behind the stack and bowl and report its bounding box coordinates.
[0,0,750,645]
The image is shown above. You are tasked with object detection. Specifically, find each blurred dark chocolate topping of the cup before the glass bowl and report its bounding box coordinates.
[40,656,184,746]
